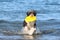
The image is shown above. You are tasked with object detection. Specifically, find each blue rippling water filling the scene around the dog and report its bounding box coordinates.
[0,0,60,40]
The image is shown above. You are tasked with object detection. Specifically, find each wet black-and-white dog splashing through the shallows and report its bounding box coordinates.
[23,11,36,35]
